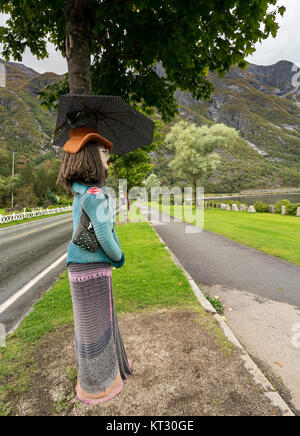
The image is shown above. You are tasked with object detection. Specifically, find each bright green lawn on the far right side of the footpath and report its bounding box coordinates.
[153,204,300,265]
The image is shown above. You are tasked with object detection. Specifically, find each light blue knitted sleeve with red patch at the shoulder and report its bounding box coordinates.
[82,188,123,262]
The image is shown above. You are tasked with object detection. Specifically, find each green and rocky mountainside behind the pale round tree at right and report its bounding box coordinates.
[164,61,300,192]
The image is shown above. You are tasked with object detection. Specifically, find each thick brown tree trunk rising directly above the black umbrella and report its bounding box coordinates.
[65,0,92,94]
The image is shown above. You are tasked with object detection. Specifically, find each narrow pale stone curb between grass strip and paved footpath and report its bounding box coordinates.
[144,221,295,416]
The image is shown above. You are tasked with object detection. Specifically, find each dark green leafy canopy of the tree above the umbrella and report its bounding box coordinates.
[0,0,285,121]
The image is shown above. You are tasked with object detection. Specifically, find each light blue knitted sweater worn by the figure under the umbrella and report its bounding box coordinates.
[67,182,125,268]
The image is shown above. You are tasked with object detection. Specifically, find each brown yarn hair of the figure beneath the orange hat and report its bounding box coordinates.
[57,141,108,194]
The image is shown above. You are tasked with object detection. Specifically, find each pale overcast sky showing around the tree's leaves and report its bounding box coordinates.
[0,0,300,74]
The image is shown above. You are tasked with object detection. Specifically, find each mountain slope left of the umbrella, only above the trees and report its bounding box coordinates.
[0,59,63,154]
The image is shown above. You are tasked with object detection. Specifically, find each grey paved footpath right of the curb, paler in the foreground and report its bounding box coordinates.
[141,206,300,411]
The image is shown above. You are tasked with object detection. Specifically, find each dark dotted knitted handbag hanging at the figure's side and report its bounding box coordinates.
[72,194,114,253]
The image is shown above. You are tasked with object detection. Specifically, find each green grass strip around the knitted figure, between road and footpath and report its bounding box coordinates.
[0,222,202,416]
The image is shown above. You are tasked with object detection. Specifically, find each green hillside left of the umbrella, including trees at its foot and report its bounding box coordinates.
[0,61,62,210]
